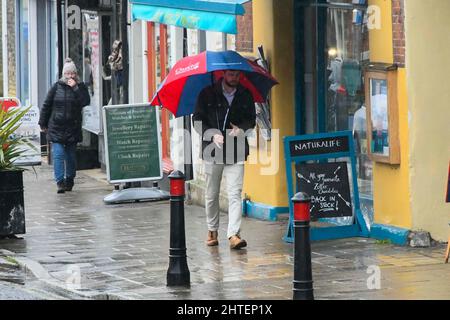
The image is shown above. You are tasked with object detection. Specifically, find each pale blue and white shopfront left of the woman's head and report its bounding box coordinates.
[1,0,58,119]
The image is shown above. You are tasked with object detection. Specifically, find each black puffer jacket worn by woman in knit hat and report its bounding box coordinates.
[39,80,91,144]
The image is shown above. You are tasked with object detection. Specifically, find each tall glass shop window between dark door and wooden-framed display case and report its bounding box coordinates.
[325,0,373,220]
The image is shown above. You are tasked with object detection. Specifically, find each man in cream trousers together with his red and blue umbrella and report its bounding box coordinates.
[150,50,278,249]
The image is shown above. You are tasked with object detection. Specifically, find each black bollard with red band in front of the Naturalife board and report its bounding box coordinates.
[292,192,314,300]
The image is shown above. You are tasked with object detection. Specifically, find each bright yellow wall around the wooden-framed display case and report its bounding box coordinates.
[369,0,411,228]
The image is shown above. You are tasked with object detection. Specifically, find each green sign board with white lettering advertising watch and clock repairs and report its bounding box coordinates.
[103,104,163,183]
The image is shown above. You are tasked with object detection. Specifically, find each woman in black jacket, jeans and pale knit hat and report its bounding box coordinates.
[39,58,91,193]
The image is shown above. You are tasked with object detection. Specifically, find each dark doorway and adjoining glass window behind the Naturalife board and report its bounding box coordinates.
[295,0,373,224]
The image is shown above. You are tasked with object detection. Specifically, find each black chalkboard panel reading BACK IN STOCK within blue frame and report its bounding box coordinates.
[296,162,353,221]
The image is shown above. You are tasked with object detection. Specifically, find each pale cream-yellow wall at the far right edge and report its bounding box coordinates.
[405,0,450,241]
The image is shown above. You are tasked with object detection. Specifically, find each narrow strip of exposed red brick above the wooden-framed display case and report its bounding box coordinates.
[392,0,406,67]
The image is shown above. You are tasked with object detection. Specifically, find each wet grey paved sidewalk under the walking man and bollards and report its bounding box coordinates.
[0,165,450,300]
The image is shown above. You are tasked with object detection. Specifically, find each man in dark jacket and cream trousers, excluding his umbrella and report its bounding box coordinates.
[192,70,256,249]
